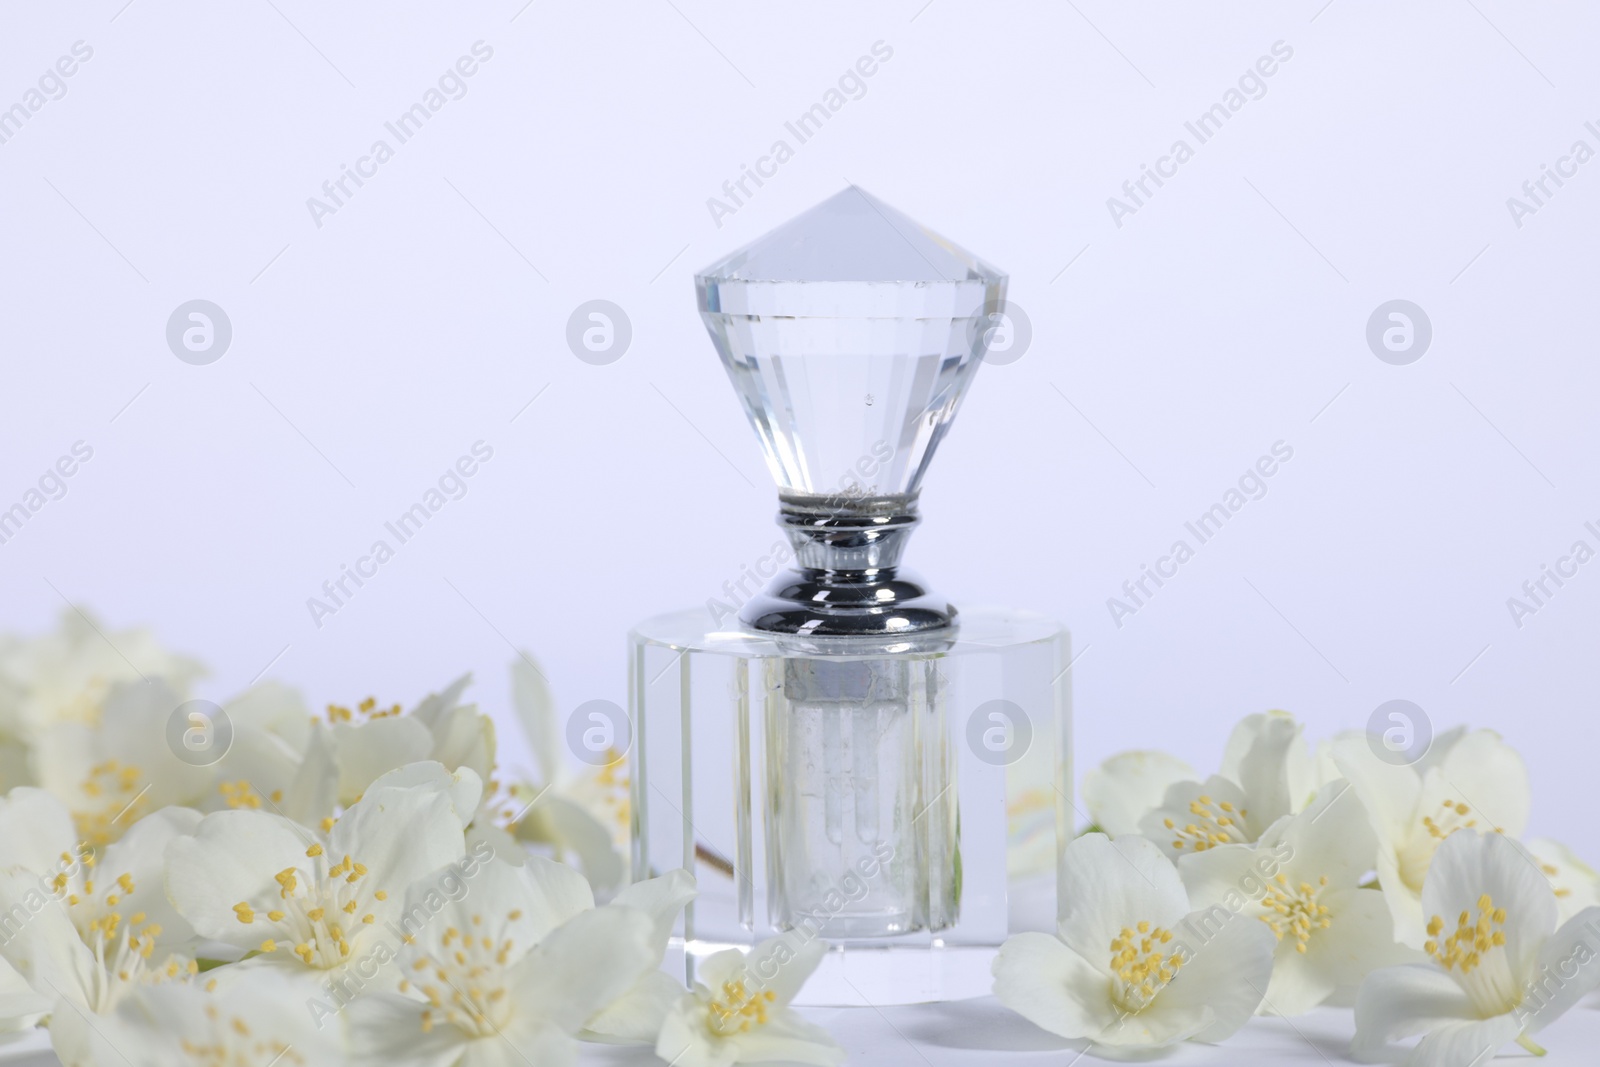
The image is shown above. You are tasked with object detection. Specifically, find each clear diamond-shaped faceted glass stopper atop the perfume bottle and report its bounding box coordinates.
[694,186,1006,501]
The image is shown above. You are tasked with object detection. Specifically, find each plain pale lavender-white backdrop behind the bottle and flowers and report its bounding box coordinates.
[0,0,1600,861]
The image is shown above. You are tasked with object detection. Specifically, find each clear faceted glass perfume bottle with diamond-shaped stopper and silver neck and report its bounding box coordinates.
[629,187,1072,1005]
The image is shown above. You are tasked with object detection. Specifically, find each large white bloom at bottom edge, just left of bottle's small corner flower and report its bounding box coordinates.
[346,857,654,1067]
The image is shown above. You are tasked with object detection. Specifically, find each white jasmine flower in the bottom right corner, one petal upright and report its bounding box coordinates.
[1350,831,1600,1067]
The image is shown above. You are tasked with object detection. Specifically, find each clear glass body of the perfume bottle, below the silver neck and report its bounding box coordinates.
[629,609,1072,1003]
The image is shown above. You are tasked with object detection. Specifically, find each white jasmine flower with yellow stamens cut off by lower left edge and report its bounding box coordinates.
[0,789,200,1067]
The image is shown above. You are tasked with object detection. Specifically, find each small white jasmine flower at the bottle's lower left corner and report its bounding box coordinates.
[656,933,845,1067]
